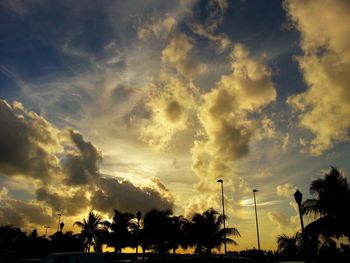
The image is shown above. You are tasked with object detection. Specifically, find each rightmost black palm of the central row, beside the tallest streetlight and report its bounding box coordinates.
[190,208,240,254]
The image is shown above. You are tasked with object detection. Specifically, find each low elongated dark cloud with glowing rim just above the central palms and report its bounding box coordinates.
[91,178,174,217]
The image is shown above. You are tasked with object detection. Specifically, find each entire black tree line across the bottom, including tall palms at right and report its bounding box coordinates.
[0,167,350,262]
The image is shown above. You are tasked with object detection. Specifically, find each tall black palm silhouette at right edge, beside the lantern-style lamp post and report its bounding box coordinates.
[302,167,350,240]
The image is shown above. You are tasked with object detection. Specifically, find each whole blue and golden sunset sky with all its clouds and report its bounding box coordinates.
[0,0,350,250]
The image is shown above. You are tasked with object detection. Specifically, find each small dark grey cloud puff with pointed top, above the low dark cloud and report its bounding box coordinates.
[62,130,102,185]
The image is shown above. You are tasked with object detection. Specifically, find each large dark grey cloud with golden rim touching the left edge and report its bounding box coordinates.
[0,100,60,181]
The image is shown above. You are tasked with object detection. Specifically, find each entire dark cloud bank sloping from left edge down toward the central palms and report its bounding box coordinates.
[0,101,174,223]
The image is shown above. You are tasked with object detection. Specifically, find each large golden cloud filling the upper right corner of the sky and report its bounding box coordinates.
[284,0,350,156]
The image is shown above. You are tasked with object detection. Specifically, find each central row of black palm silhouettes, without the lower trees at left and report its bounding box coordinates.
[75,208,239,255]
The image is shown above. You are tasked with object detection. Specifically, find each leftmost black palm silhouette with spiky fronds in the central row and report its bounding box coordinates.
[73,211,104,252]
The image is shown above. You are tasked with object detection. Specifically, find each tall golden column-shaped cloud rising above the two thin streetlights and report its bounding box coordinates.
[192,44,276,190]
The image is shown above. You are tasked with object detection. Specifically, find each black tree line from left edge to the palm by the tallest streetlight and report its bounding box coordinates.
[0,208,240,262]
